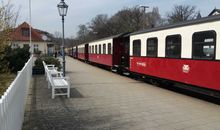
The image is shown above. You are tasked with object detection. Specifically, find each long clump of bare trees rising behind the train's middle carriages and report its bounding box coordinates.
[74,6,161,43]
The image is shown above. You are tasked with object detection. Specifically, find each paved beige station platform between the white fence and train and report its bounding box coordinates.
[23,57,220,130]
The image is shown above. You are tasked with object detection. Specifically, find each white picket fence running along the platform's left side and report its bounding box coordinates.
[0,57,33,130]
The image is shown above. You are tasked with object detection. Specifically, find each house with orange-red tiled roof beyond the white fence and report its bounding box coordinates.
[11,22,54,54]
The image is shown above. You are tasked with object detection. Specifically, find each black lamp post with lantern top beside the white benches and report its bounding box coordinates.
[57,0,68,76]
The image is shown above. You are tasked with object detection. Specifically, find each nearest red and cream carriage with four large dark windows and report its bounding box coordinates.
[130,16,220,95]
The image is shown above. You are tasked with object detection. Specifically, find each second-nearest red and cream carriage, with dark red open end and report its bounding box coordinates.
[89,34,128,68]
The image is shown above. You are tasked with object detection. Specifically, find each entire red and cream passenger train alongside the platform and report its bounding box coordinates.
[68,15,220,97]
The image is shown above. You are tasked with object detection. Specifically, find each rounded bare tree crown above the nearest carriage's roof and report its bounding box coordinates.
[167,5,199,24]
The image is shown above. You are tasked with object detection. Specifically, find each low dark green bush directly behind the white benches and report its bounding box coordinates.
[33,56,61,74]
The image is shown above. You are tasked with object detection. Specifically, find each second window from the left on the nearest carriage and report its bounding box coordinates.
[147,38,158,57]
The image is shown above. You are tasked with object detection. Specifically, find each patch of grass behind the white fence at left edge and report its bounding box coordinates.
[0,73,16,98]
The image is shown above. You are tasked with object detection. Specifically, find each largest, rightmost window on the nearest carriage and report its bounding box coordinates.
[192,31,216,60]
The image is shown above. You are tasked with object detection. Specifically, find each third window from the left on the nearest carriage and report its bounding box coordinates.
[166,35,181,58]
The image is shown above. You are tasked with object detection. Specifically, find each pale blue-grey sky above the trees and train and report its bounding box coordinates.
[4,0,220,37]
